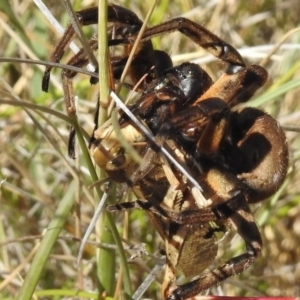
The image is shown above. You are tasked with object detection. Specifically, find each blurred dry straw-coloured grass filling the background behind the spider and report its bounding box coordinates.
[0,0,300,299]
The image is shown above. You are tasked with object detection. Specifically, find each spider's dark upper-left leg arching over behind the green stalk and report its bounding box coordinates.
[42,4,164,92]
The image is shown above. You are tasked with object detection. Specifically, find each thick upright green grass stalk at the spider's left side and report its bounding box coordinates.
[95,1,132,295]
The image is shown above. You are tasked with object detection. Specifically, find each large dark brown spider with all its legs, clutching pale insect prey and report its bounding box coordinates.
[43,5,288,300]
